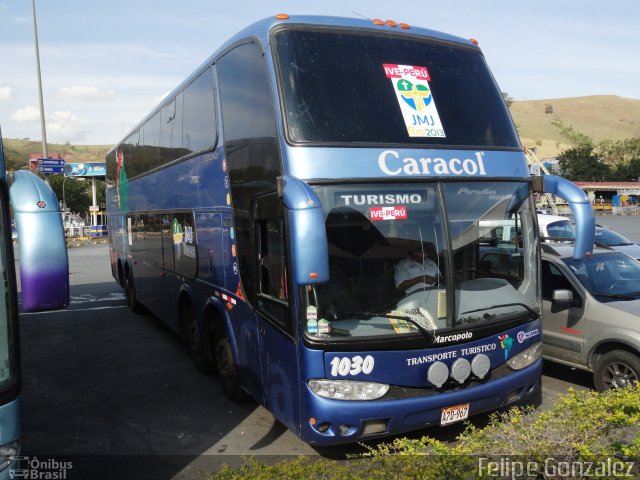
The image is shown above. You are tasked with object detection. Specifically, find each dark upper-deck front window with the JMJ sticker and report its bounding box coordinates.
[273,26,519,148]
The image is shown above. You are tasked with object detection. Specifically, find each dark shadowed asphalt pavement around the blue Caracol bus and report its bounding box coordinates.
[15,232,608,480]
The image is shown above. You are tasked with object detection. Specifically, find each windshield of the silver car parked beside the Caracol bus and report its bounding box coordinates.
[563,252,640,298]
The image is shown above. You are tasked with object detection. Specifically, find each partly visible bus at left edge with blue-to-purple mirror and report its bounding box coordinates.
[0,127,69,479]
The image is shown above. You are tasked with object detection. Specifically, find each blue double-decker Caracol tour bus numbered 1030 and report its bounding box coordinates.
[106,15,594,445]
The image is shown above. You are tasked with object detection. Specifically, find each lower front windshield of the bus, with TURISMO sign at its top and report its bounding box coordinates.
[304,182,539,340]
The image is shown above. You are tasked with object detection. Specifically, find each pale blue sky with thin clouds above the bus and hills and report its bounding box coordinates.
[0,0,640,145]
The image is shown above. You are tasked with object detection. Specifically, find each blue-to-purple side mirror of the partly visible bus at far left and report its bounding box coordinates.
[9,170,69,312]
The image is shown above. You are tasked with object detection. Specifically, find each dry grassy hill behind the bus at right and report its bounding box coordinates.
[510,95,640,158]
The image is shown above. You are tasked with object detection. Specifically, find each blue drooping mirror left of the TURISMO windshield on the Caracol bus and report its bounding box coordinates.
[278,175,329,285]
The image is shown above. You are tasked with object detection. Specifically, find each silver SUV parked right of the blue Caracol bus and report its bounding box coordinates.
[541,243,640,391]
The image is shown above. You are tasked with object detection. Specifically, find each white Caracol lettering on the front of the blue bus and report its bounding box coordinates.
[378,150,487,176]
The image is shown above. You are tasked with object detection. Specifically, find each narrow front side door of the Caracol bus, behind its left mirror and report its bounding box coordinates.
[255,194,299,430]
